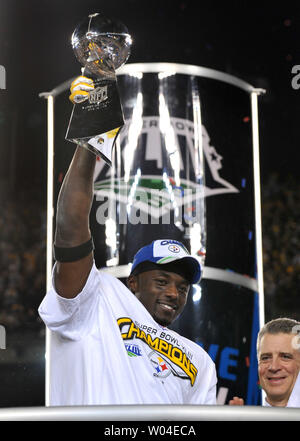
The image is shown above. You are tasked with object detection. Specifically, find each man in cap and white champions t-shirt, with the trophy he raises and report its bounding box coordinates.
[39,14,217,406]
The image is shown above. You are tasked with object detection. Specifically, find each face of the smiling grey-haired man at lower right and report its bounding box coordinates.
[258,333,300,406]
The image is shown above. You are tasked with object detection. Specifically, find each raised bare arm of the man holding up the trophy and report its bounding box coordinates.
[54,147,96,298]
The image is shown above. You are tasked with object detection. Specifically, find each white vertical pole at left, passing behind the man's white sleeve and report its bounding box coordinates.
[45,95,54,406]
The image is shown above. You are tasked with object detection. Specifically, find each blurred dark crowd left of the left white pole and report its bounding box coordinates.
[0,193,46,330]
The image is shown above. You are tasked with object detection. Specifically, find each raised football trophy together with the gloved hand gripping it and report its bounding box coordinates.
[66,13,132,165]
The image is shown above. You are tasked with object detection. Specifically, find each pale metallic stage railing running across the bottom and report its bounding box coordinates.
[0,405,300,422]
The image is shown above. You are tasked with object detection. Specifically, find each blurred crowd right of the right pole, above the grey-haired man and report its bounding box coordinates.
[262,173,300,320]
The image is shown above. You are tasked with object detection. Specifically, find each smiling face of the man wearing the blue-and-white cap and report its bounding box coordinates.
[128,270,190,326]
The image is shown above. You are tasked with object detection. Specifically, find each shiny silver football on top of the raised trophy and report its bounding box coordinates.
[71,13,132,75]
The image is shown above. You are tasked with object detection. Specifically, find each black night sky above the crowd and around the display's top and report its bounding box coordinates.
[0,0,300,195]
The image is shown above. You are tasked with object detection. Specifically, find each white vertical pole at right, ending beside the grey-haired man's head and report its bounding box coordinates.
[251,90,265,328]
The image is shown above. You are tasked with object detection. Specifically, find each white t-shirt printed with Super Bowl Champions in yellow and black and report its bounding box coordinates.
[39,264,217,406]
